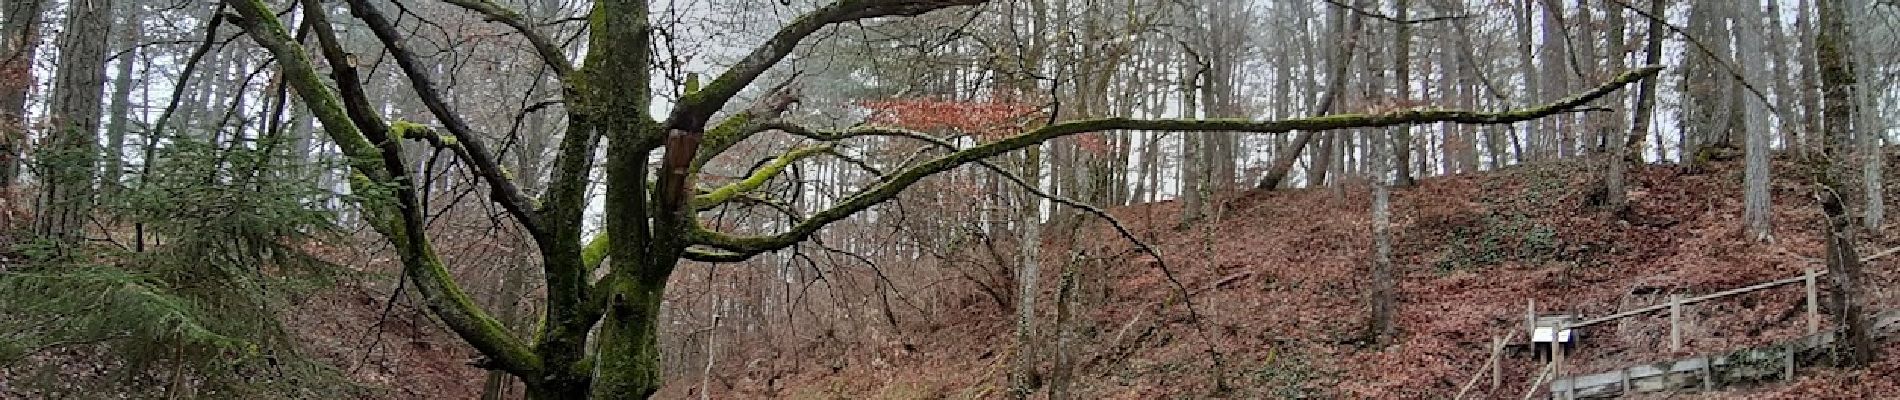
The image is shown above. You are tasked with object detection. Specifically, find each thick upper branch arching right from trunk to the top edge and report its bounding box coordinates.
[667,0,988,133]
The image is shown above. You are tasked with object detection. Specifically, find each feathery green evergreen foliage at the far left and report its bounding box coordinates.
[0,138,363,398]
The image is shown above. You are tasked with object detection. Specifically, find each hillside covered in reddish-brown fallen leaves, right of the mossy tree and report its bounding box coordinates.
[661,154,1900,398]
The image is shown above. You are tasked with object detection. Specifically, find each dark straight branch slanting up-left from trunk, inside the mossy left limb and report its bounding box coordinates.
[350,0,547,241]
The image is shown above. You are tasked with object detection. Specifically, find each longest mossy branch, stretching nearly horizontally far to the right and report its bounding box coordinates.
[692,66,1663,254]
